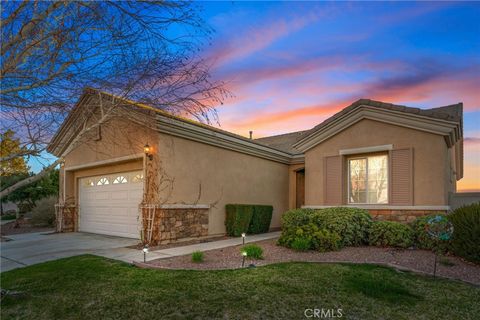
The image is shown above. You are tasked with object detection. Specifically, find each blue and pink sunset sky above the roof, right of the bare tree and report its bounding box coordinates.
[198,2,480,191]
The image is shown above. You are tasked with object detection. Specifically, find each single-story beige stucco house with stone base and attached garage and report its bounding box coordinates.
[48,89,463,242]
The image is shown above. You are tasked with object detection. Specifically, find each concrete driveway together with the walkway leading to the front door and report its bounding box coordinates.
[0,232,280,272]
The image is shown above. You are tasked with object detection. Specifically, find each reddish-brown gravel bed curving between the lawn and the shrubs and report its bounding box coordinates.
[145,239,480,285]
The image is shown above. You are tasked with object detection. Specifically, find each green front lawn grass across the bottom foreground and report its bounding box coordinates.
[1,255,480,320]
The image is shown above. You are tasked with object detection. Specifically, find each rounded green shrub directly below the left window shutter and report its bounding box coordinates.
[312,207,372,246]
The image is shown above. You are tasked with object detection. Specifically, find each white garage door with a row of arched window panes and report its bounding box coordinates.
[78,171,143,239]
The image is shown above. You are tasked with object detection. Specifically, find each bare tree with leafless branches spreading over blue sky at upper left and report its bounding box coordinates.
[0,1,228,195]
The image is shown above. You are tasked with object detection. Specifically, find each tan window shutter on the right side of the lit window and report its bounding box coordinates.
[390,149,413,205]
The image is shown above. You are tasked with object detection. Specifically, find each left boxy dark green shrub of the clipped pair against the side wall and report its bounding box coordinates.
[225,204,253,237]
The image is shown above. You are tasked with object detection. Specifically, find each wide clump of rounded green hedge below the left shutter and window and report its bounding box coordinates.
[278,207,372,250]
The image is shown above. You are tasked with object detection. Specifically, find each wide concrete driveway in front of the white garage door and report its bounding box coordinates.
[0,232,169,272]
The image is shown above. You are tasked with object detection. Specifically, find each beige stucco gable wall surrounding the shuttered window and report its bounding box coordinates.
[305,119,452,205]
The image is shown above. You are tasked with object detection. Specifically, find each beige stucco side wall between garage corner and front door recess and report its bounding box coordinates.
[159,134,289,234]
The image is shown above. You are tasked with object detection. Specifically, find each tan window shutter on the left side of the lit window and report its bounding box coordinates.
[324,156,343,205]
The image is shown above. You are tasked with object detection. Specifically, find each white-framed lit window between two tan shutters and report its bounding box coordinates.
[348,154,388,204]
